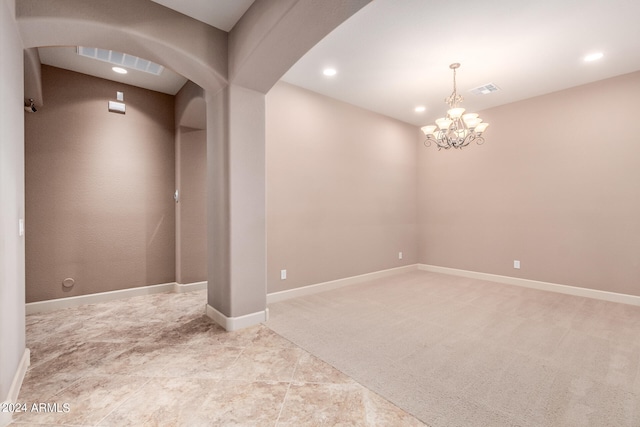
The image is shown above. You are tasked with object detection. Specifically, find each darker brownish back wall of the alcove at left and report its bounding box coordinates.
[25,66,175,302]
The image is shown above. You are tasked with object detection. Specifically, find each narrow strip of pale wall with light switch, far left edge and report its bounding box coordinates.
[0,0,28,404]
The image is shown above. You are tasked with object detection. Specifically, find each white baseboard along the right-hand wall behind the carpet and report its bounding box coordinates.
[418,264,640,306]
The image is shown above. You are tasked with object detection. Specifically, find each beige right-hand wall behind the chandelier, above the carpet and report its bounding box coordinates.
[419,72,640,295]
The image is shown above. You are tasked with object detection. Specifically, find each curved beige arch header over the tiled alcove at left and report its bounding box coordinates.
[16,0,228,93]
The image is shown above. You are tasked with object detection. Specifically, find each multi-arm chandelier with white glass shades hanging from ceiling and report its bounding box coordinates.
[421,63,489,150]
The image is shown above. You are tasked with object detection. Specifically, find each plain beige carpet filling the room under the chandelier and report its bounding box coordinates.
[267,271,640,427]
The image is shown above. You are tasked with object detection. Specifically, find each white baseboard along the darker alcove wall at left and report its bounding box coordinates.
[25,282,207,314]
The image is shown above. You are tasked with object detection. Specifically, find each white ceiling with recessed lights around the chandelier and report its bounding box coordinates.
[36,0,640,125]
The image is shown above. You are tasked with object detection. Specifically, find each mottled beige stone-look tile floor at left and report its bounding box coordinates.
[11,291,423,427]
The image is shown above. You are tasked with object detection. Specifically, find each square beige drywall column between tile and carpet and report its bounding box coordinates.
[207,85,267,327]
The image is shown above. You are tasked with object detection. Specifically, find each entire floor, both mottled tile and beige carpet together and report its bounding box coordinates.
[14,271,640,427]
